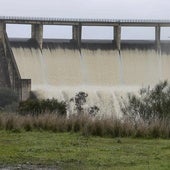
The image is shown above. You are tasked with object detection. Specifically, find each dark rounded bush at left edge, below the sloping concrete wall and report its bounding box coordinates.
[0,88,19,109]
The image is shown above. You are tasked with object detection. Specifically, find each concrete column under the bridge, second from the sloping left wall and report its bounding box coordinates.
[72,24,82,47]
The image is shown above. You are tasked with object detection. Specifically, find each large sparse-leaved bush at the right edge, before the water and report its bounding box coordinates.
[121,81,170,120]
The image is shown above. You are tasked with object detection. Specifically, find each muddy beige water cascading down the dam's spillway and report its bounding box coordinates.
[12,42,170,114]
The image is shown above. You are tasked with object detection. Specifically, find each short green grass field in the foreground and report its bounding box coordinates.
[0,131,170,170]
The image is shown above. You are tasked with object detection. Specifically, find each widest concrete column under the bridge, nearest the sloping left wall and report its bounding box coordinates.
[31,24,43,49]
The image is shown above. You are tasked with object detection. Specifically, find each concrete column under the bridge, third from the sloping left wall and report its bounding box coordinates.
[114,25,121,50]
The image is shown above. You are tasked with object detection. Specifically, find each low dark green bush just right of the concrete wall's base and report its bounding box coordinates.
[18,99,66,115]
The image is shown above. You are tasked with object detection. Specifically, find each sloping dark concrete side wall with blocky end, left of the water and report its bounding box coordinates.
[0,22,31,100]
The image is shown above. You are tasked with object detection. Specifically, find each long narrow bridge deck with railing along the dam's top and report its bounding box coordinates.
[0,16,170,27]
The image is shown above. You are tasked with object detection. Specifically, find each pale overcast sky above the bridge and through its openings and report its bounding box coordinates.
[0,0,170,39]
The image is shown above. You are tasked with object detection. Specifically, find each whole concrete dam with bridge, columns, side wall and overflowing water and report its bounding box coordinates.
[0,17,170,114]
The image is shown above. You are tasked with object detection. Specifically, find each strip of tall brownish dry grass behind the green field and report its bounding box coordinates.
[0,113,170,138]
